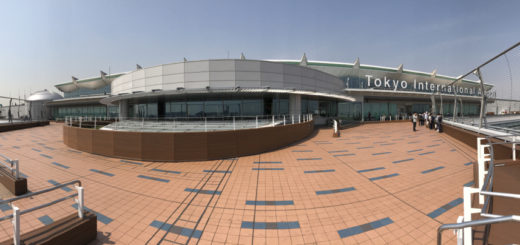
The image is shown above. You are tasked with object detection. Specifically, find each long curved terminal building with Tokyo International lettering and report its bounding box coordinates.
[47,55,492,124]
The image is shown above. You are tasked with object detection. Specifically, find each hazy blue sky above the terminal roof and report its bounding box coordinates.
[0,0,520,103]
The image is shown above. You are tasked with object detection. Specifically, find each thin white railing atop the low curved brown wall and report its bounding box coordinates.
[65,114,313,132]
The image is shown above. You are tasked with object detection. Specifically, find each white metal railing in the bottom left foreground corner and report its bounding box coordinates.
[0,180,84,245]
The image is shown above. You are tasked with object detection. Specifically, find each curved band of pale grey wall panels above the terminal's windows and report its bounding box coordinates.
[112,60,343,98]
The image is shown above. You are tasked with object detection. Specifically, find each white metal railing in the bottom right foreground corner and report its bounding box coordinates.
[437,134,520,245]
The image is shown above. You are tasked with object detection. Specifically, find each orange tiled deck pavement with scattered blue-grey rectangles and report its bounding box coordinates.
[0,123,476,244]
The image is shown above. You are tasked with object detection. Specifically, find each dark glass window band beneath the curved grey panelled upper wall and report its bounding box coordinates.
[123,94,361,121]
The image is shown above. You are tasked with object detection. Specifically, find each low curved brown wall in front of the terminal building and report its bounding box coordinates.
[63,121,314,161]
